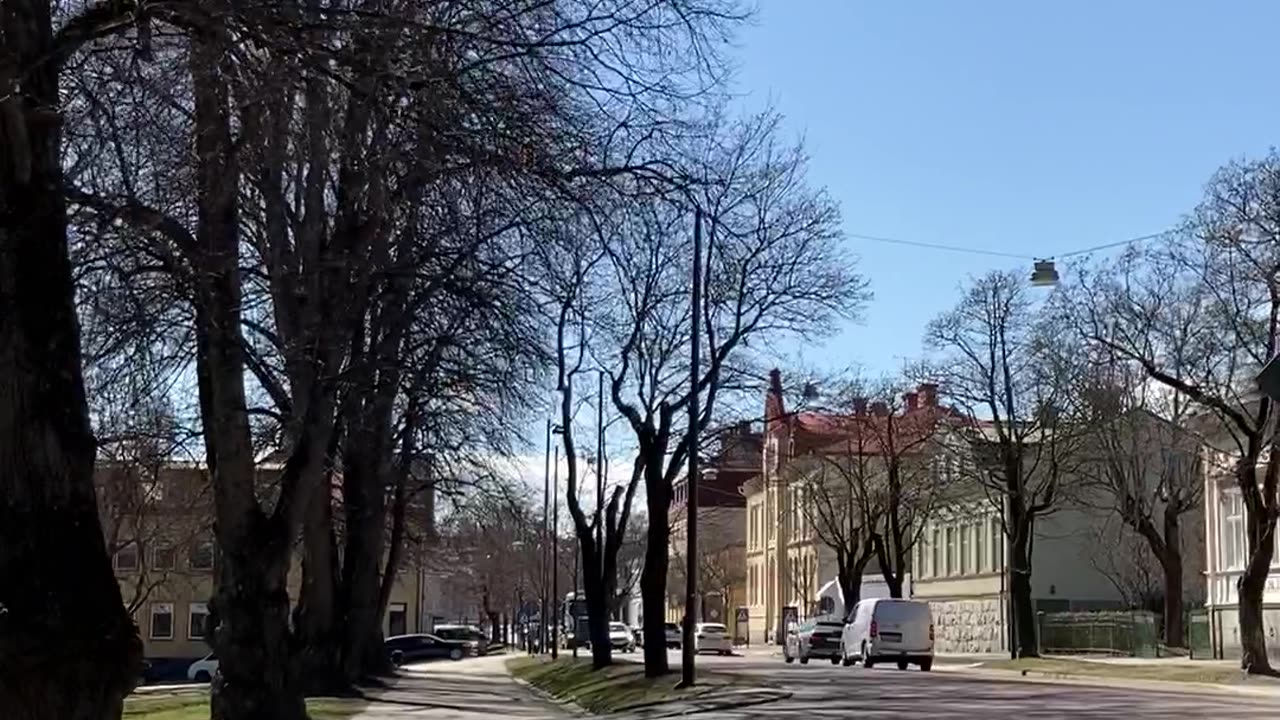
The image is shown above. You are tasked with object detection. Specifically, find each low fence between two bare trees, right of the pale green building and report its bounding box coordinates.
[1039,610,1160,657]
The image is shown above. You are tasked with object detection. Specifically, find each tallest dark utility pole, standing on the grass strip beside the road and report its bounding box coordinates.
[680,208,703,688]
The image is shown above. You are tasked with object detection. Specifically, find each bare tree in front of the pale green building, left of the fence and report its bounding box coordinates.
[925,272,1078,657]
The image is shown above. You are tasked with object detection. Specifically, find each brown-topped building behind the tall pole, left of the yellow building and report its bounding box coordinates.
[667,421,760,637]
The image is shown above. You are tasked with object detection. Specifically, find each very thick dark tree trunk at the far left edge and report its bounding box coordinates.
[0,0,142,720]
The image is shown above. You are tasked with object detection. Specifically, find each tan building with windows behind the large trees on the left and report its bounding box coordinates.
[95,462,425,675]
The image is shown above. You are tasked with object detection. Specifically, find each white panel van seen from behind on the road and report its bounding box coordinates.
[840,598,933,671]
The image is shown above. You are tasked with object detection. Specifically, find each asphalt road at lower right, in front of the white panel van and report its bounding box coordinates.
[673,655,1280,720]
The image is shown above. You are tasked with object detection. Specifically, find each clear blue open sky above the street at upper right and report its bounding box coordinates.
[736,0,1280,373]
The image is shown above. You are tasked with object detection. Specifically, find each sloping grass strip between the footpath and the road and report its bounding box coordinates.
[507,657,744,714]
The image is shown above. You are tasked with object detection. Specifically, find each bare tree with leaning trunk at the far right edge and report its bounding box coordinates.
[1074,152,1280,674]
